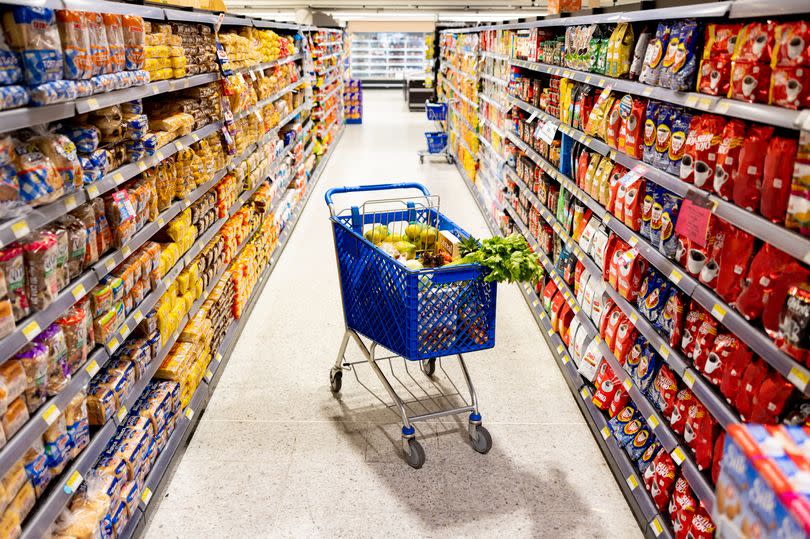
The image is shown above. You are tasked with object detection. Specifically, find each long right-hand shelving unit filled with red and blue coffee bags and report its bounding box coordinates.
[437,0,810,538]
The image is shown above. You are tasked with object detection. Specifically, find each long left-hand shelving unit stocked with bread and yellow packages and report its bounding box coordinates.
[0,1,342,538]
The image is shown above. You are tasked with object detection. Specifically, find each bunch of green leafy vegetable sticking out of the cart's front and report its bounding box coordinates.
[461,234,543,284]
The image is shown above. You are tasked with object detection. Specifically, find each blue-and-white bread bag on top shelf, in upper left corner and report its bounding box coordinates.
[3,6,64,86]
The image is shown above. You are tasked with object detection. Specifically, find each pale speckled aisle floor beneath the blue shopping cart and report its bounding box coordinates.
[147,91,640,538]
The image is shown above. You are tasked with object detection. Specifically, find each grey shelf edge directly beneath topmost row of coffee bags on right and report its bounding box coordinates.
[510,57,806,129]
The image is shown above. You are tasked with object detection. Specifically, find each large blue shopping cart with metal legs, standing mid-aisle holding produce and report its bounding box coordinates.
[325,183,497,468]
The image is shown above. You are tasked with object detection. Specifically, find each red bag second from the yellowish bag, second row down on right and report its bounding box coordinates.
[731,125,773,211]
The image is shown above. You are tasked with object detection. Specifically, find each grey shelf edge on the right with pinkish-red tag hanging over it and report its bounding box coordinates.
[507,92,810,270]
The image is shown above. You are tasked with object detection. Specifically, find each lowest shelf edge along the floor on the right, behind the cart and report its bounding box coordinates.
[456,144,672,537]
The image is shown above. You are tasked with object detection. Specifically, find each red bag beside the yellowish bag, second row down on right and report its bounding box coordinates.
[759,137,798,224]
